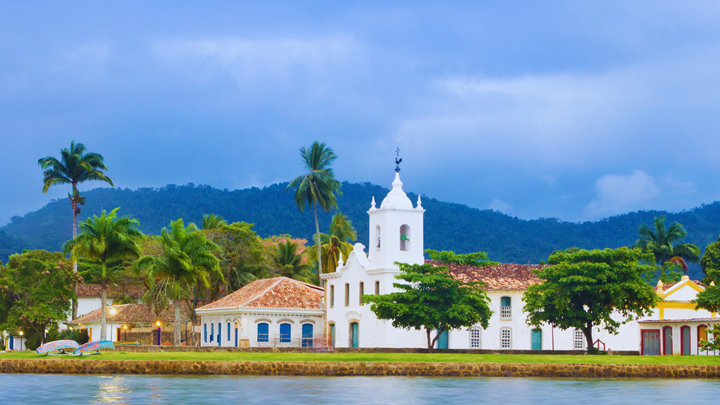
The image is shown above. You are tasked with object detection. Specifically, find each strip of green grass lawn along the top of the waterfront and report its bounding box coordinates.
[0,350,720,365]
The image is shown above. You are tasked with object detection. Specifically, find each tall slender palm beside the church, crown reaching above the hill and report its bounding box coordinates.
[285,141,342,274]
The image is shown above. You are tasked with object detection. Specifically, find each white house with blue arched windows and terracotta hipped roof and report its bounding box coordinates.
[196,277,325,347]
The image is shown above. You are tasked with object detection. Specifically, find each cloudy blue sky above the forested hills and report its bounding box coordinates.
[0,0,720,225]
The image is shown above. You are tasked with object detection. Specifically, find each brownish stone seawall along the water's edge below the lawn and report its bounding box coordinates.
[0,359,720,378]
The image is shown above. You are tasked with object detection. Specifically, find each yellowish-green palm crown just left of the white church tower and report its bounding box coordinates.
[308,212,357,273]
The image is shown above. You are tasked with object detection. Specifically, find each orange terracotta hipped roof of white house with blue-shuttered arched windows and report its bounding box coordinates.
[198,277,324,310]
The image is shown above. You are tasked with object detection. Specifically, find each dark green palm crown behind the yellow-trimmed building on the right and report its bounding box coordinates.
[635,215,700,272]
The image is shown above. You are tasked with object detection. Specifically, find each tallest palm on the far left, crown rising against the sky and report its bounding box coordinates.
[38,141,114,319]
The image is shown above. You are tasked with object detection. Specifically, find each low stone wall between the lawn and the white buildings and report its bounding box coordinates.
[117,345,640,356]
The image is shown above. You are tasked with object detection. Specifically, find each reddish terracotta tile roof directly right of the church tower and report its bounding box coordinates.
[425,260,549,291]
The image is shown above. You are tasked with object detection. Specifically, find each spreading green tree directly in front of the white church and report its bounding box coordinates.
[363,262,493,353]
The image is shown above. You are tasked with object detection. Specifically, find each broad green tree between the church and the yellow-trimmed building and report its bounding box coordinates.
[523,247,658,353]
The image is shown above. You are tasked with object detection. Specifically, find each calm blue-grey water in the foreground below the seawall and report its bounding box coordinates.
[0,374,720,405]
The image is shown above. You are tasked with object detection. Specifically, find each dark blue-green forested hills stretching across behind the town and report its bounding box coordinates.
[0,183,720,280]
